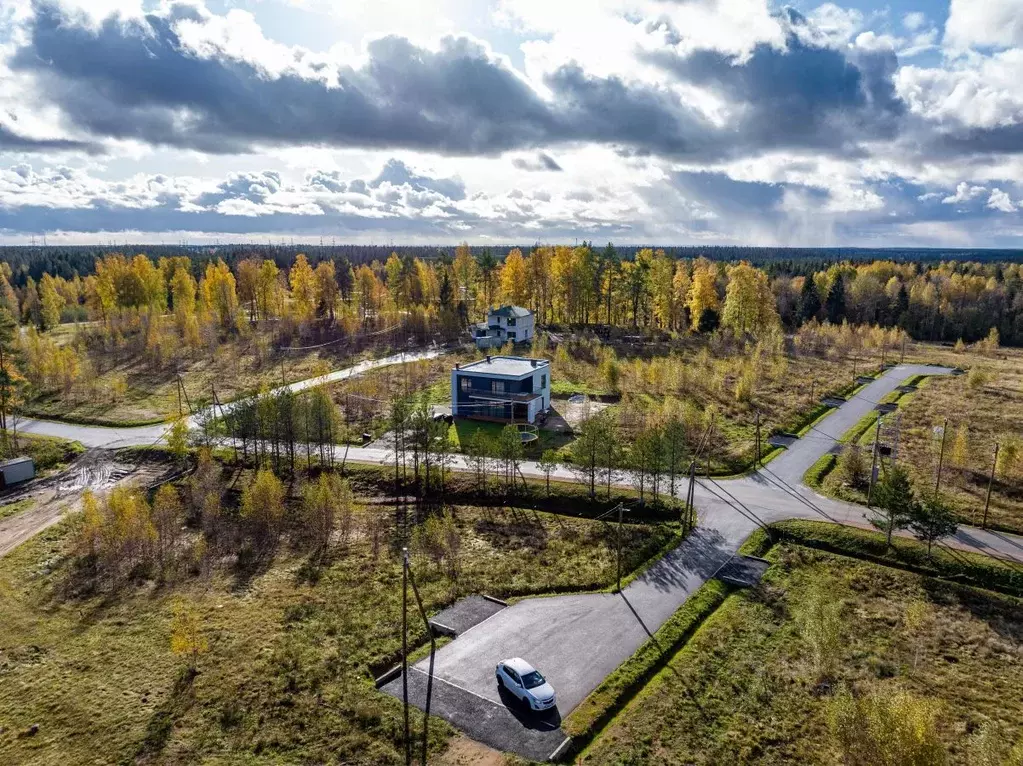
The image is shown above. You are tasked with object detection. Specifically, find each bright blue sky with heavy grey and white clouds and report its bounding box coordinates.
[0,0,1023,247]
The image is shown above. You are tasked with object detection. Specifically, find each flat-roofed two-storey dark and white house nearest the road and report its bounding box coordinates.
[451,356,550,423]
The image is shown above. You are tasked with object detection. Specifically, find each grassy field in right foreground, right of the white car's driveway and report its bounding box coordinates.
[580,531,1023,764]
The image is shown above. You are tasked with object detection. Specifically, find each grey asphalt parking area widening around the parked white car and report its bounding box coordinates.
[381,529,749,761]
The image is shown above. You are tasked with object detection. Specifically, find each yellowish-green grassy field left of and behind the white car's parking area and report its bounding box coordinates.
[0,506,670,766]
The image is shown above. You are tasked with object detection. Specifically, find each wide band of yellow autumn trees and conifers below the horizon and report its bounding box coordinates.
[0,243,1023,425]
